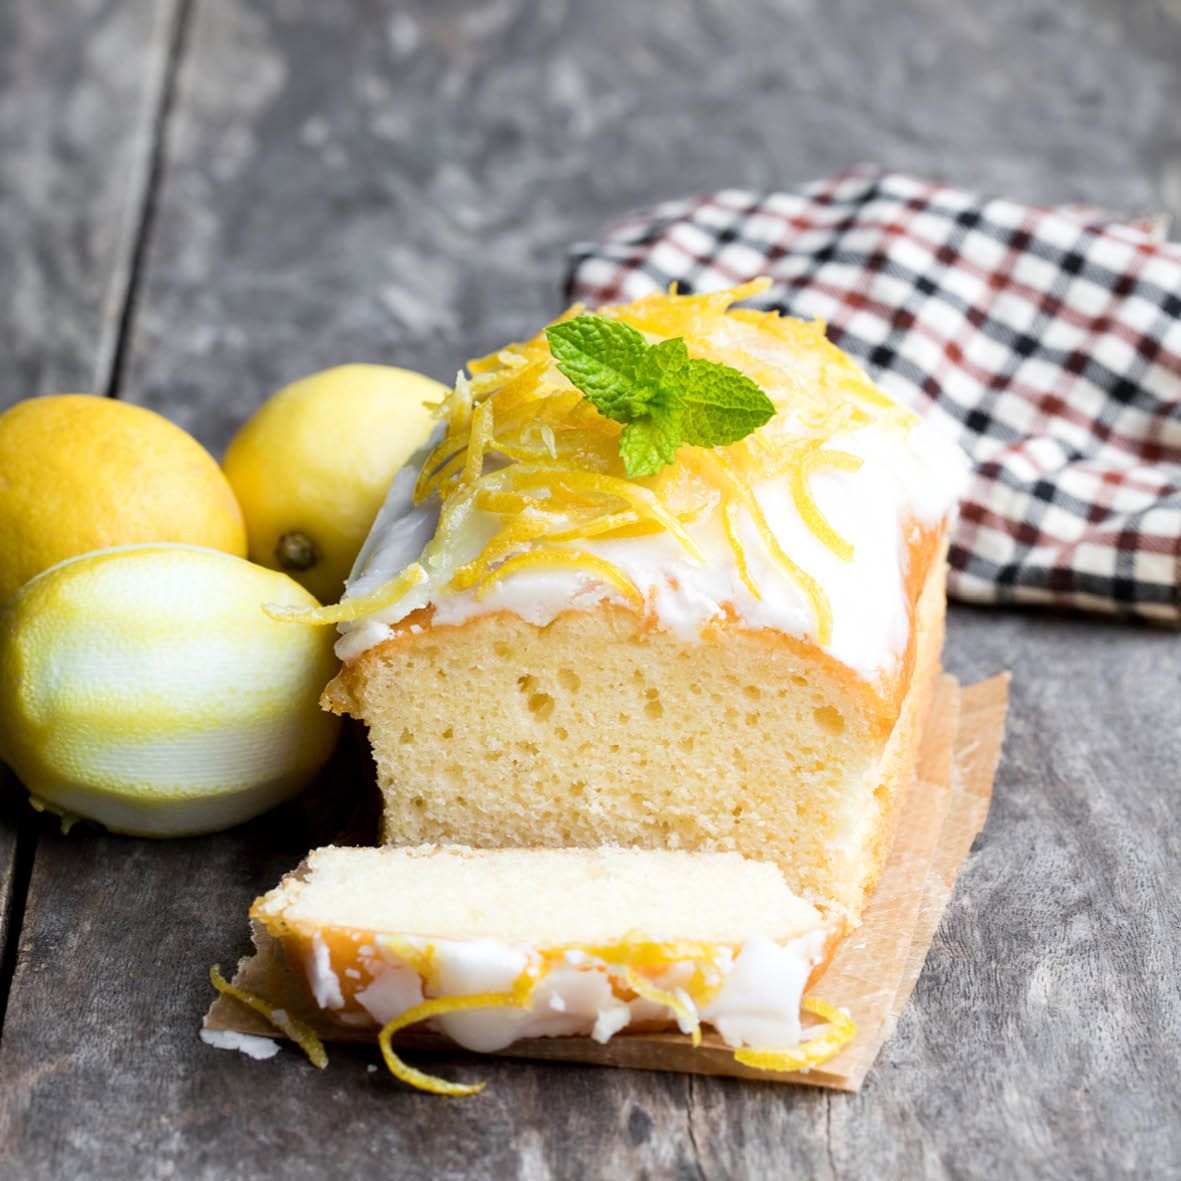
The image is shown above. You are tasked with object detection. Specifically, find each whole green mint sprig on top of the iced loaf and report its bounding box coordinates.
[546,315,775,479]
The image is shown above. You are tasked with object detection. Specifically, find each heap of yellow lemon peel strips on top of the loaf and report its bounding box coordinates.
[274,278,918,644]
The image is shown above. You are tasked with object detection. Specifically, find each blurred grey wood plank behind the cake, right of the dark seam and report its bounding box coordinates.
[117,0,1181,450]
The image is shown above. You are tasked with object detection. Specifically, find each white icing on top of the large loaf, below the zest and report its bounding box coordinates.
[337,415,967,680]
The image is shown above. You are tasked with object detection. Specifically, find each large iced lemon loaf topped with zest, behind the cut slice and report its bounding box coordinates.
[324,283,964,924]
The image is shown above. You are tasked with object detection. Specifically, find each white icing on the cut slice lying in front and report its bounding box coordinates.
[306,928,828,1052]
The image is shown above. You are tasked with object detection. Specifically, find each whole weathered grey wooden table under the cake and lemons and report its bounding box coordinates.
[0,0,1181,1179]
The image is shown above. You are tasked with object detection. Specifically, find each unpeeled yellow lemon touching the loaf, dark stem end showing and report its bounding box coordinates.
[222,365,448,602]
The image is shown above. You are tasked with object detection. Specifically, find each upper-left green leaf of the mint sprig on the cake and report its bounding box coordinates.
[546,315,648,423]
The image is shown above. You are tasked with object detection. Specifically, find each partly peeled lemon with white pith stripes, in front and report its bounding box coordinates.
[0,544,338,836]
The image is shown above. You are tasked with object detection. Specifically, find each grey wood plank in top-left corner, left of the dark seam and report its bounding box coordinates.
[0,0,181,410]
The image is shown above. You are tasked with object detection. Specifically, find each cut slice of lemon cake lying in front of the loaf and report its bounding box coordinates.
[252,847,853,1090]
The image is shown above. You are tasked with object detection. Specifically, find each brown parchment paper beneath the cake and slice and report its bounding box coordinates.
[204,676,1009,1091]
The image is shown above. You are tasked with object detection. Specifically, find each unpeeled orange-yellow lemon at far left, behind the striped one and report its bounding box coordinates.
[0,393,246,602]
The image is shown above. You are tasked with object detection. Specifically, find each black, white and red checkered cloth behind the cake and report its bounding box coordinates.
[568,169,1181,622]
